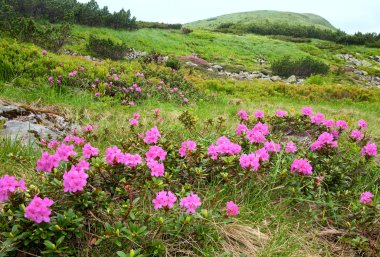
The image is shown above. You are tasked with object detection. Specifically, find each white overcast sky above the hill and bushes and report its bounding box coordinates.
[79,0,380,33]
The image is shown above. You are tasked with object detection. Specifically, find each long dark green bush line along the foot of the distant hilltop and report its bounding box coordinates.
[215,22,380,47]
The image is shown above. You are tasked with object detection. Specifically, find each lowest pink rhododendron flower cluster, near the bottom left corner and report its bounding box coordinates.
[24,195,54,223]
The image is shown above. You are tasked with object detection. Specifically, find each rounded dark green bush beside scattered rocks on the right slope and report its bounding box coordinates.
[272,56,329,77]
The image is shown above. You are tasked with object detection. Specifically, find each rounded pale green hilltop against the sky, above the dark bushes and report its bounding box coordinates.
[185,10,336,30]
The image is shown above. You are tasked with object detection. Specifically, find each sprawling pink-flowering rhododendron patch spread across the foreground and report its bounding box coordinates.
[0,107,380,256]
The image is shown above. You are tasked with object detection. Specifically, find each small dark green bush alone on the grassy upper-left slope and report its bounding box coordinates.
[87,35,128,60]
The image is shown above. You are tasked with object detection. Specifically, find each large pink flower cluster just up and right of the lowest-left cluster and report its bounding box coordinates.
[63,166,88,193]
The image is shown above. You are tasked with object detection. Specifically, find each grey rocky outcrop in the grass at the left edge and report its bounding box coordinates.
[0,100,77,144]
